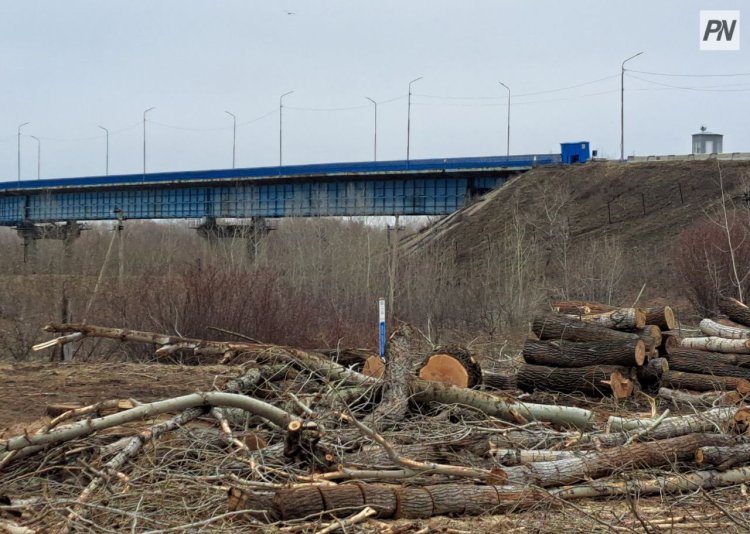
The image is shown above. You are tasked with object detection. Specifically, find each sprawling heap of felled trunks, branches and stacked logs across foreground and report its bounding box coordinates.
[0,320,750,532]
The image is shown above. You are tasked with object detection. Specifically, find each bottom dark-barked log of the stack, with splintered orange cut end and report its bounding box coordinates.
[516,364,634,399]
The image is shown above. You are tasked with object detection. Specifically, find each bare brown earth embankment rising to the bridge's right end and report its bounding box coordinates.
[403,161,750,308]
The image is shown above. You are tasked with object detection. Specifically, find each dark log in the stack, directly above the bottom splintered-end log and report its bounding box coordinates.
[523,339,646,367]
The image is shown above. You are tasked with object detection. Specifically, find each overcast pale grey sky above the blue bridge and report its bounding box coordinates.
[0,0,750,180]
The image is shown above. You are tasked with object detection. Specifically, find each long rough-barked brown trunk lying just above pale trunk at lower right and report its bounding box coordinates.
[496,434,740,487]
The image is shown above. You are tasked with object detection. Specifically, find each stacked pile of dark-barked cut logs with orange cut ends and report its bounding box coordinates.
[484,301,679,399]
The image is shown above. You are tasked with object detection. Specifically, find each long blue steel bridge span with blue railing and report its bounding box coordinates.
[0,153,568,227]
